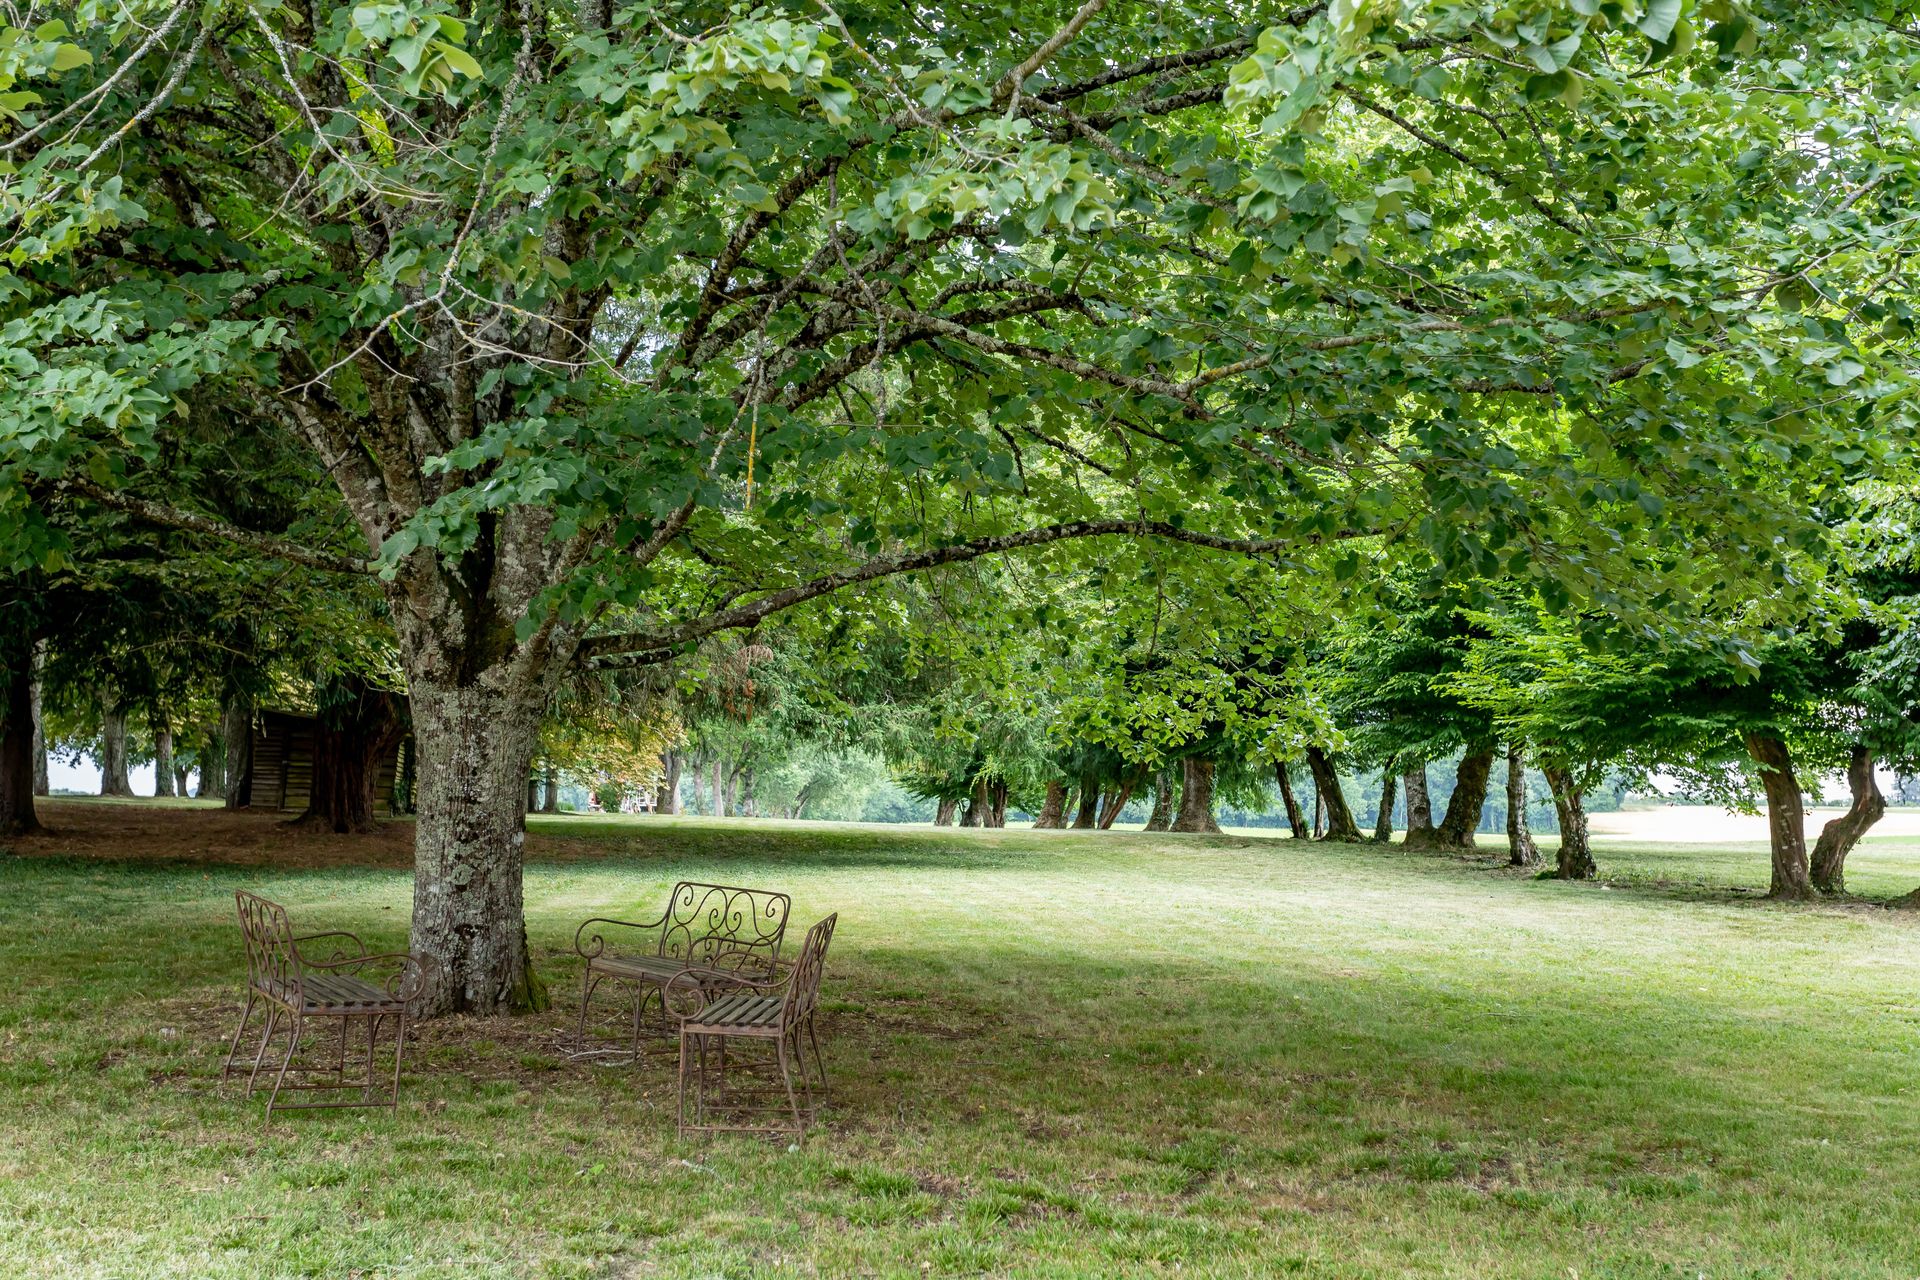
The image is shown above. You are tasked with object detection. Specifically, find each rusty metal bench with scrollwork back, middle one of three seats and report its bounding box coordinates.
[574,881,791,1061]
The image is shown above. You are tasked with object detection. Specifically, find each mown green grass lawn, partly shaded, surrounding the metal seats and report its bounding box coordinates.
[0,810,1920,1280]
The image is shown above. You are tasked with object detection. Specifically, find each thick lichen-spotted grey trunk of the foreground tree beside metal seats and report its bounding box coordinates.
[411,679,545,1013]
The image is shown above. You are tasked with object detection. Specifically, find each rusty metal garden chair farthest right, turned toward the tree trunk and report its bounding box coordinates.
[662,913,839,1140]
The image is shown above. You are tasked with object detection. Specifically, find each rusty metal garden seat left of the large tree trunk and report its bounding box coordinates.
[221,890,426,1125]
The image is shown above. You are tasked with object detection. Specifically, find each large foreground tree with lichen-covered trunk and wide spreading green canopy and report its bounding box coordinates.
[0,0,1920,1011]
